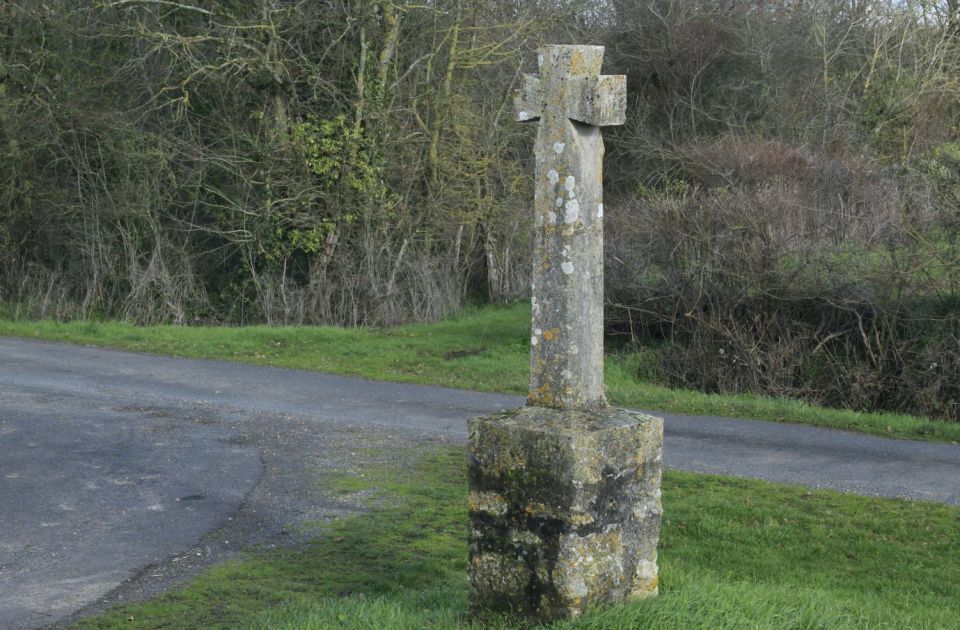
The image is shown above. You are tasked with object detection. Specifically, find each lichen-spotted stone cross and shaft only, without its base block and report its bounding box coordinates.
[514,46,626,409]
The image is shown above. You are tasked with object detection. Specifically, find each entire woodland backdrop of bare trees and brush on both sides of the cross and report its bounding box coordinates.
[0,0,960,419]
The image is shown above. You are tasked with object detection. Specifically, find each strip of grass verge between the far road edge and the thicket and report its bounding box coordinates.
[0,303,960,443]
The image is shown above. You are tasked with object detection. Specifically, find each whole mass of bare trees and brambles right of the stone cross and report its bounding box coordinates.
[607,2,960,420]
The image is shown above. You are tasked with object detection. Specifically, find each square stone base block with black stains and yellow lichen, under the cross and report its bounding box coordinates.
[468,407,663,622]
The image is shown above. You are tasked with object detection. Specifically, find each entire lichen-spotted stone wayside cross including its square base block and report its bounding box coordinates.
[467,46,663,623]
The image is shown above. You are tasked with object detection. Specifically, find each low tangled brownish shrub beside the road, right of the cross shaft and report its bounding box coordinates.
[608,142,960,420]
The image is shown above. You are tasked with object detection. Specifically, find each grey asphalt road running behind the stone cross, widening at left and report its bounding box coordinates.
[0,339,960,629]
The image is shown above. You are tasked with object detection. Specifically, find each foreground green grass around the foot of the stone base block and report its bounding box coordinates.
[73,448,960,630]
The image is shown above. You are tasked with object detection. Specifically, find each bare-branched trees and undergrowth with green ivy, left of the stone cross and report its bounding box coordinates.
[0,0,552,325]
